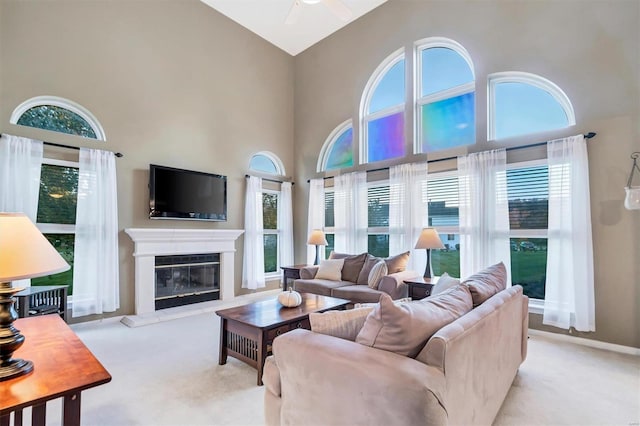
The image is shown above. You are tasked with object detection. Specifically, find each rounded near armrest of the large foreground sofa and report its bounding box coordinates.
[265,329,447,425]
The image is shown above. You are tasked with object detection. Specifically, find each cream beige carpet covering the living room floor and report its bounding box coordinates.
[25,314,640,426]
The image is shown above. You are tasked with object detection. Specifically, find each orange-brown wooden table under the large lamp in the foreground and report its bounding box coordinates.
[0,315,111,426]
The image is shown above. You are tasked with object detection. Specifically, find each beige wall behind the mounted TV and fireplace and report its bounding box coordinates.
[0,0,294,315]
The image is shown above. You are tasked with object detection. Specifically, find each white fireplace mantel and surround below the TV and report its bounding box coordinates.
[122,228,244,326]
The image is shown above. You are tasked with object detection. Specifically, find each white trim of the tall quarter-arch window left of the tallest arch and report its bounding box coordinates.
[358,47,406,164]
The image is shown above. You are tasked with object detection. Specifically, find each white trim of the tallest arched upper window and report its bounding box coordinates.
[413,37,476,154]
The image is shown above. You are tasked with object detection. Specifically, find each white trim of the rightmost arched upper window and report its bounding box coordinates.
[487,71,576,141]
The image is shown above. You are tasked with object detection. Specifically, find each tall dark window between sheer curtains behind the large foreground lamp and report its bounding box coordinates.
[31,158,79,295]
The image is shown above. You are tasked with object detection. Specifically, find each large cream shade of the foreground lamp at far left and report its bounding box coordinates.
[0,213,69,282]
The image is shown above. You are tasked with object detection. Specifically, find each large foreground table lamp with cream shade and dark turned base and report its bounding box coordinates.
[0,213,69,381]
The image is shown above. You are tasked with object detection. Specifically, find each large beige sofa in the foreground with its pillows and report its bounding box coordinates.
[263,264,528,425]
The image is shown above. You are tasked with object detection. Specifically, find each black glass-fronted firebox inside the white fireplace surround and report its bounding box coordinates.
[155,253,220,310]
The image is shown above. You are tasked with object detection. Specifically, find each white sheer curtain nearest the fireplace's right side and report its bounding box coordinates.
[242,176,265,290]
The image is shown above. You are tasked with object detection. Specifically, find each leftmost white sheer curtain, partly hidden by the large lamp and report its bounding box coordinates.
[0,134,42,287]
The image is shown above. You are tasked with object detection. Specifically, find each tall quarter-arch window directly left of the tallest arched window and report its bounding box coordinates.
[360,49,405,163]
